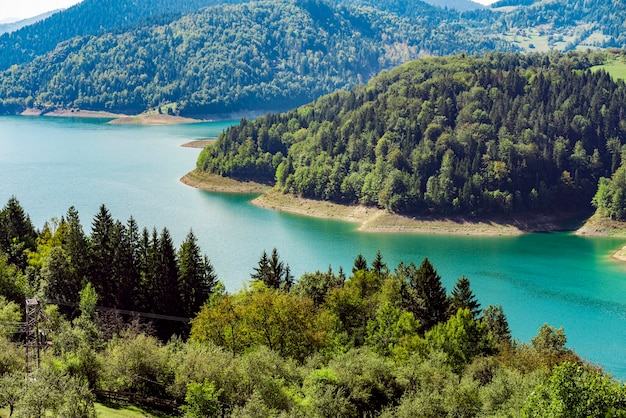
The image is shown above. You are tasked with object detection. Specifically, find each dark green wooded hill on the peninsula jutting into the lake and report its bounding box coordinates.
[197,53,626,214]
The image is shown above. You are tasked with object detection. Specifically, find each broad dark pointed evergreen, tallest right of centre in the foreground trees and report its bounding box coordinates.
[397,258,450,332]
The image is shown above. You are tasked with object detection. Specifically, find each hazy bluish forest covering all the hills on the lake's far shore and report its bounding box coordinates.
[0,0,626,118]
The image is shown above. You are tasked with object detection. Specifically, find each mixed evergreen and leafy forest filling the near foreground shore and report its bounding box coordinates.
[0,197,626,418]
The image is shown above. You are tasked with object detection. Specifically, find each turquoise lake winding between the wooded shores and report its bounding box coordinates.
[0,116,626,379]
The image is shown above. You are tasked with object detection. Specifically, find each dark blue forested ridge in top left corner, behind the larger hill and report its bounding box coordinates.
[0,0,247,70]
